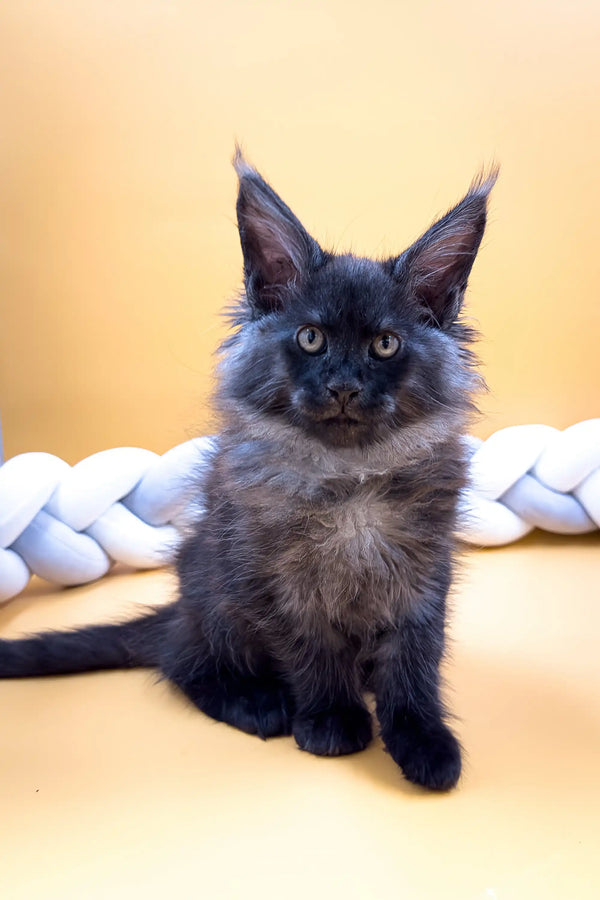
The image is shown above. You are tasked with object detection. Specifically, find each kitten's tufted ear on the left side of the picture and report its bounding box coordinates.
[233,148,322,313]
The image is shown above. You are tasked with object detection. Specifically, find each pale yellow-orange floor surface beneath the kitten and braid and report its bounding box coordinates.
[0,535,600,900]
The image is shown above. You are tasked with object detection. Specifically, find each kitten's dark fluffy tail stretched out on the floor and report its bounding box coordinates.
[0,604,175,678]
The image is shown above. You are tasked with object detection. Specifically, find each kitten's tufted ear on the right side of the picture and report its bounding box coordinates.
[392,169,498,328]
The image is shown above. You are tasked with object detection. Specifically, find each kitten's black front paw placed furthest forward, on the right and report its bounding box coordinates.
[382,722,461,791]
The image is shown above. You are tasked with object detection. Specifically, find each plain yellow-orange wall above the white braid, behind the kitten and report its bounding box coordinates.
[0,0,600,462]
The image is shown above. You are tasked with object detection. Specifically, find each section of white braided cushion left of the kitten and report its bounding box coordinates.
[0,438,213,602]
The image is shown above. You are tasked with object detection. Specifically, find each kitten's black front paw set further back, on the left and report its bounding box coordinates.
[292,706,373,756]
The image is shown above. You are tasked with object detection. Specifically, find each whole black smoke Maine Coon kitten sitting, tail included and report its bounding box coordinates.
[0,153,495,790]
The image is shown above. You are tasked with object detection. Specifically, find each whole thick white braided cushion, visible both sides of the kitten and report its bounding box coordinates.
[0,419,600,602]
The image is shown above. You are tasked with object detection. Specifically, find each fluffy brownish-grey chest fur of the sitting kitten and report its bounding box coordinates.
[211,420,460,634]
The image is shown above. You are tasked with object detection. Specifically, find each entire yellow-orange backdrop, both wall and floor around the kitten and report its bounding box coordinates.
[0,0,600,900]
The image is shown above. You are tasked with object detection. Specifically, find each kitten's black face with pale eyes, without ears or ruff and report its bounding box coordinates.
[280,257,411,446]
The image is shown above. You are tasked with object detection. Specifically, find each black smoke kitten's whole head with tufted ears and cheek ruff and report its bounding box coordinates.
[221,153,496,447]
